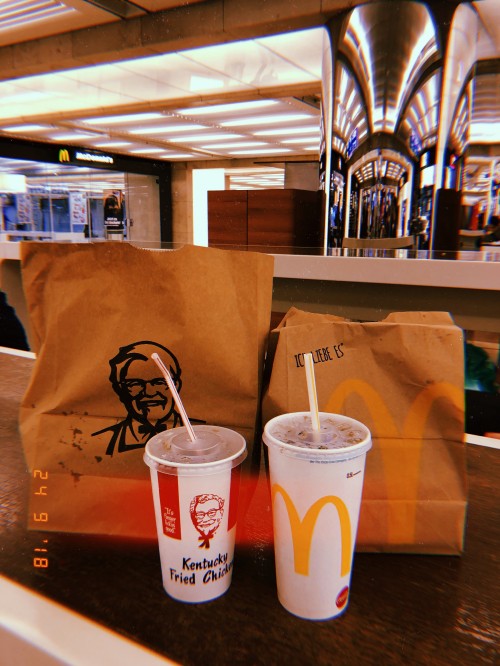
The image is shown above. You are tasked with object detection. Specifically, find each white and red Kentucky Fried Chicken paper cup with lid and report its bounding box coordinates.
[144,425,246,603]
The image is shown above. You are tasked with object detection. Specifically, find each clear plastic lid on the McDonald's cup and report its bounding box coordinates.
[262,412,372,460]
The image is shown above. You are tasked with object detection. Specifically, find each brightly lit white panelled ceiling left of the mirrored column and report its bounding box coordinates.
[0,1,323,187]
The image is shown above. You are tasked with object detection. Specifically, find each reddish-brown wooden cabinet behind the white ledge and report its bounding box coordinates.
[208,190,324,254]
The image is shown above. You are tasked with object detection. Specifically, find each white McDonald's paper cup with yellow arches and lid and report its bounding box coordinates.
[263,412,371,620]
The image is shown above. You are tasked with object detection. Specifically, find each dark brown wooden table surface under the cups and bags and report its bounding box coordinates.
[0,354,500,666]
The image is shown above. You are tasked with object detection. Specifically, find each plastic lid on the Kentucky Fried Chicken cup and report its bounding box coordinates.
[144,425,247,474]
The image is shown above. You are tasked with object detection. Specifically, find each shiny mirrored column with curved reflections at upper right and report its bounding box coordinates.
[320,0,500,251]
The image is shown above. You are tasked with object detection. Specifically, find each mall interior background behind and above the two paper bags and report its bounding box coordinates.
[0,0,500,436]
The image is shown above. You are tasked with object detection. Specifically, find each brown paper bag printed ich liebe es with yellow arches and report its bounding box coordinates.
[263,308,467,554]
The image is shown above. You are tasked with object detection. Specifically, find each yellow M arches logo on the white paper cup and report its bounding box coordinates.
[271,483,352,576]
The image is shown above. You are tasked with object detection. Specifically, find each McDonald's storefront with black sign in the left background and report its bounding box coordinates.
[0,141,172,243]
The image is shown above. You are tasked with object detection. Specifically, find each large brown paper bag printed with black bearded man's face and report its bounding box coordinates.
[20,242,273,538]
